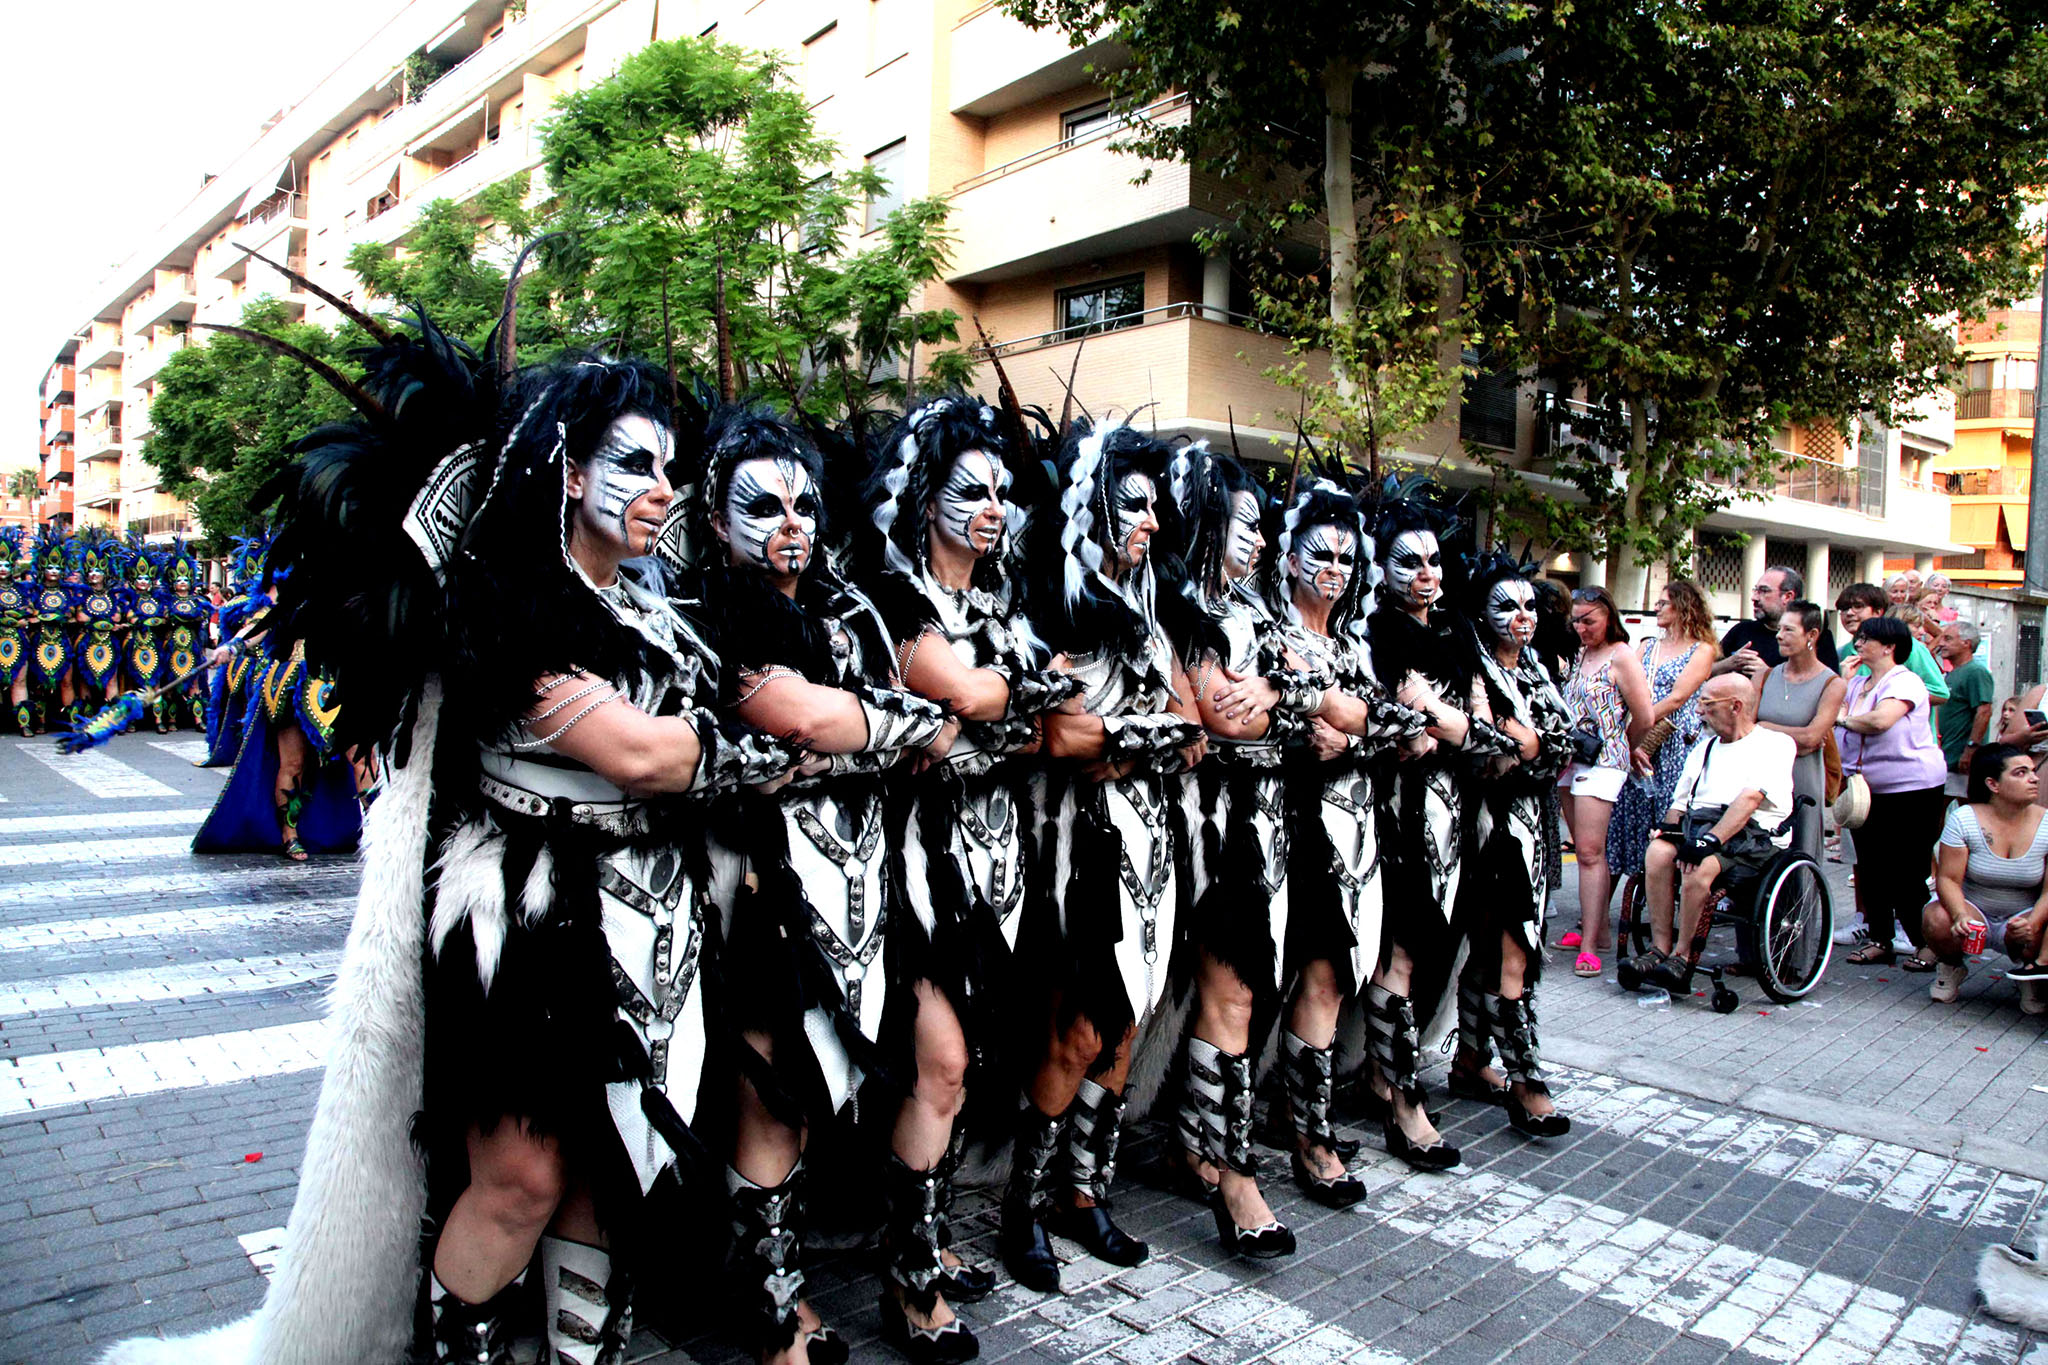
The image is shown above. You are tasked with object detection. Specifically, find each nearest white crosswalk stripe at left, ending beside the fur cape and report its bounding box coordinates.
[0,1019,328,1115]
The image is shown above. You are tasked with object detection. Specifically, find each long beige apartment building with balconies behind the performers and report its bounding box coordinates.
[32,0,1966,610]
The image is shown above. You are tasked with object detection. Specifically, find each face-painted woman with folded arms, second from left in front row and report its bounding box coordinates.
[692,407,954,1365]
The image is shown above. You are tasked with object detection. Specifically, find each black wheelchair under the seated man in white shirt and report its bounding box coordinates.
[1614,796,1835,1015]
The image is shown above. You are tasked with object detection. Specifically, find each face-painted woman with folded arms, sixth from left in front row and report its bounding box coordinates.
[1268,479,1436,1207]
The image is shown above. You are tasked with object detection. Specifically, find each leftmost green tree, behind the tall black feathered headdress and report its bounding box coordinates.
[141,299,358,544]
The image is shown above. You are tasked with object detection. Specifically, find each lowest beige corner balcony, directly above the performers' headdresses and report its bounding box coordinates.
[973,303,1327,452]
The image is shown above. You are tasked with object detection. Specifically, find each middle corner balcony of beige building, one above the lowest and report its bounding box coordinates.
[946,96,1227,284]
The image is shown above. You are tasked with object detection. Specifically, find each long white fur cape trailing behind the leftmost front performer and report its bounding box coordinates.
[100,695,440,1365]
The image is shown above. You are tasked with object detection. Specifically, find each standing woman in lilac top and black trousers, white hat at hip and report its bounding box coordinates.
[1835,616,1948,966]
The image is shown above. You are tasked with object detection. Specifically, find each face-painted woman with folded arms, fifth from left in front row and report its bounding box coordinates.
[1167,442,1323,1259]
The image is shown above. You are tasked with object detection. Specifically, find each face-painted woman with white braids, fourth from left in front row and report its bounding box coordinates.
[1001,424,1206,1293]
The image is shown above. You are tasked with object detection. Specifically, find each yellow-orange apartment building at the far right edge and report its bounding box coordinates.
[1933,295,2042,587]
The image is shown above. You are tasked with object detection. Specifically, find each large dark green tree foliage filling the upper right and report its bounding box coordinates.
[1008,0,2048,597]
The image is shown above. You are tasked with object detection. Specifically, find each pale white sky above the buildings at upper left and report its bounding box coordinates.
[0,0,406,480]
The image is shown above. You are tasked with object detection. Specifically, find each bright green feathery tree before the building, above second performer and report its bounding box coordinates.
[541,39,971,429]
